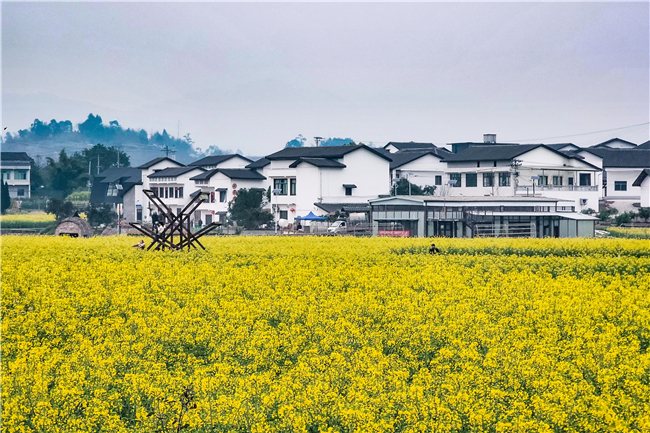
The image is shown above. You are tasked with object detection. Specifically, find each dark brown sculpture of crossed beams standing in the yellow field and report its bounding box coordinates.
[129,189,221,251]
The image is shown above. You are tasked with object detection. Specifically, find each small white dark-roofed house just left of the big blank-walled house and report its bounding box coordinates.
[190,168,266,224]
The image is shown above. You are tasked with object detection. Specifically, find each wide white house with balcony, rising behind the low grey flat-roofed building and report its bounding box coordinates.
[441,144,601,211]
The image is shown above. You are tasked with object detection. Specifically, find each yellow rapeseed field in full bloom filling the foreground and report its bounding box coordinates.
[1,236,650,432]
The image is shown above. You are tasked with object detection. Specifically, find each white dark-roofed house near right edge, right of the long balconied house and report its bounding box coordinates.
[578,147,650,212]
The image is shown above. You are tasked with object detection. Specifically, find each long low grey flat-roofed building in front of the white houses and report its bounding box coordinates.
[370,196,597,238]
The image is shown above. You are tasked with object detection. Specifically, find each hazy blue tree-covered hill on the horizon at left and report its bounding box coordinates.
[2,113,226,167]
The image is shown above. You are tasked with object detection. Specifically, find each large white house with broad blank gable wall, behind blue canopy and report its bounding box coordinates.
[260,145,391,223]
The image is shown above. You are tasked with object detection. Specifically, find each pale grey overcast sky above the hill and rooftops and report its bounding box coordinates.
[2,1,650,155]
